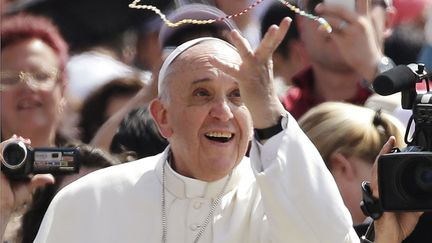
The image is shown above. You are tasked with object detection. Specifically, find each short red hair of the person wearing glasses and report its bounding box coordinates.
[0,14,69,80]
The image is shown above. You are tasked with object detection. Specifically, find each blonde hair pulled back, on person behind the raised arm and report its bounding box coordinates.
[299,102,406,167]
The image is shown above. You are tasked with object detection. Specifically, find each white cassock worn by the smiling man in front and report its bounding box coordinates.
[35,116,359,243]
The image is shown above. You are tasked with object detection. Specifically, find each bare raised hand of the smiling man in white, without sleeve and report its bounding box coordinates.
[212,18,291,134]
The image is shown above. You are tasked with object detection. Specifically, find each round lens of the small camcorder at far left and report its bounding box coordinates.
[3,142,27,169]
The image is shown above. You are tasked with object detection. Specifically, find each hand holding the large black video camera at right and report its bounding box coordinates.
[371,136,422,243]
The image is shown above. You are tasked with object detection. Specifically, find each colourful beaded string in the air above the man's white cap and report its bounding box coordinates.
[129,0,332,33]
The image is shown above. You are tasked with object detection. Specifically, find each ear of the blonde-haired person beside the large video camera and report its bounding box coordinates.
[328,152,355,181]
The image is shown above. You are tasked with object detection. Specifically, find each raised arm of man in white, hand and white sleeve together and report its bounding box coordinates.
[211,18,359,242]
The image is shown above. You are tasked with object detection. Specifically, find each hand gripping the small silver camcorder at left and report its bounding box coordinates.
[0,135,54,239]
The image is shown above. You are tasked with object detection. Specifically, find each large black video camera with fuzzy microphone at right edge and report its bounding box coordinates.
[373,64,432,211]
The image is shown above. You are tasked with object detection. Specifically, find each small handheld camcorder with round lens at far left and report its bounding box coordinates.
[1,141,80,180]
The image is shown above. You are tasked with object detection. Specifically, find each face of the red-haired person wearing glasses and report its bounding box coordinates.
[0,39,64,146]
